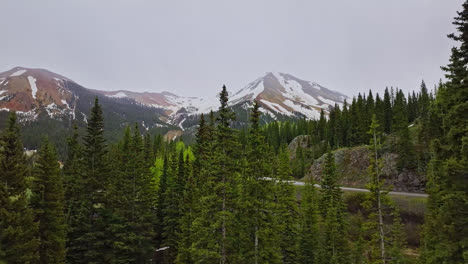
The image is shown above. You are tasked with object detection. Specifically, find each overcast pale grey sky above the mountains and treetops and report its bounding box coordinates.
[0,0,463,99]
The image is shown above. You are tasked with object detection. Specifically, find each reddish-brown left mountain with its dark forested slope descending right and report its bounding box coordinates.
[0,67,176,156]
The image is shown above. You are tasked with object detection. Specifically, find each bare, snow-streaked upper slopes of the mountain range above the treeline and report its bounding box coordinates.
[0,67,348,130]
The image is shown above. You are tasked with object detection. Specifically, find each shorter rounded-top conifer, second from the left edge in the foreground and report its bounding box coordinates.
[33,138,66,264]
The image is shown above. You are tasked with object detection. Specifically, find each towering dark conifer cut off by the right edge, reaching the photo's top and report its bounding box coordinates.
[422,1,468,263]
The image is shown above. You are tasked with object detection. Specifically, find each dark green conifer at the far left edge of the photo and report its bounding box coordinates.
[0,112,39,263]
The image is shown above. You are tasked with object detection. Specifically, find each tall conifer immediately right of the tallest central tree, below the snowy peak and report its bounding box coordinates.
[236,103,280,263]
